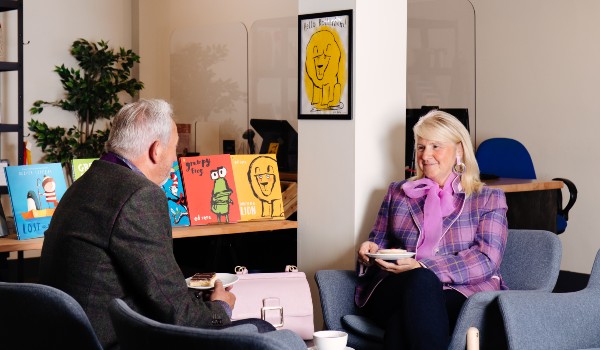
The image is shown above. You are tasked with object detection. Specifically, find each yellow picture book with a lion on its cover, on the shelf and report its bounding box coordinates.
[231,154,285,221]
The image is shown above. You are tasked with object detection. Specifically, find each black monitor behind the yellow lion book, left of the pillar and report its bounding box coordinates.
[250,119,298,172]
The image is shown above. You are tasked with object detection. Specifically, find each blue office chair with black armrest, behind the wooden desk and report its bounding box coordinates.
[475,137,577,234]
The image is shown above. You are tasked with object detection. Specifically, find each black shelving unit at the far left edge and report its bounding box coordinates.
[0,0,25,193]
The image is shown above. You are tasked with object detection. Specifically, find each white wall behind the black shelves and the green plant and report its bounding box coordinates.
[0,0,131,256]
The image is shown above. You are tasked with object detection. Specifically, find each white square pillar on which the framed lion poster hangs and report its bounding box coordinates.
[298,0,406,327]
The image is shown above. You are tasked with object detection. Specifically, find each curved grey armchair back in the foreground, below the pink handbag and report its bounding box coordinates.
[109,299,306,350]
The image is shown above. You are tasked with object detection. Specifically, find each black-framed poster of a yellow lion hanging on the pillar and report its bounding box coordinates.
[298,10,352,120]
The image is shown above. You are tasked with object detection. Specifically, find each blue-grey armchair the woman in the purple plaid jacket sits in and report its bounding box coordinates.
[315,230,561,350]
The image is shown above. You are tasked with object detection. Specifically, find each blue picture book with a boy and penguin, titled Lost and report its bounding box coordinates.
[4,163,67,239]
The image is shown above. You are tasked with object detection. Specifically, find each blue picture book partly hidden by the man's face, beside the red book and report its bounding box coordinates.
[162,161,190,227]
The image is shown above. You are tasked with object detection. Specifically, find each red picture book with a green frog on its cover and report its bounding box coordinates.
[179,154,240,225]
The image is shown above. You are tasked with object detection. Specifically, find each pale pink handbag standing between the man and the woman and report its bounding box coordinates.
[231,266,315,340]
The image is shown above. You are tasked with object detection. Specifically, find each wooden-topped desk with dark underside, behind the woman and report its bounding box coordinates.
[484,178,564,232]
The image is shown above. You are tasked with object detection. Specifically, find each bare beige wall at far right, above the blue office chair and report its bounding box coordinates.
[473,0,600,273]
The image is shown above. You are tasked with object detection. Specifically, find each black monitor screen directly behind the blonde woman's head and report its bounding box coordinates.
[404,106,470,179]
